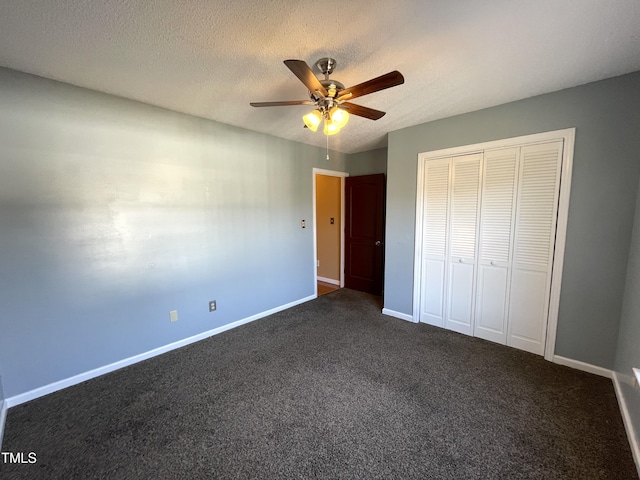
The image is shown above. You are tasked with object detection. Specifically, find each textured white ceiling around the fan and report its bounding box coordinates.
[0,0,640,153]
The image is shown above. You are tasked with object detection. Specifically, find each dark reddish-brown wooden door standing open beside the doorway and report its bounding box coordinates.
[344,174,385,295]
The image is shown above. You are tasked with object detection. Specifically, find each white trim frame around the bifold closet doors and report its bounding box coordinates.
[413,128,576,361]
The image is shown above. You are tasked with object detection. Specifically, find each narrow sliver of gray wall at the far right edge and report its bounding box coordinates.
[615,178,640,443]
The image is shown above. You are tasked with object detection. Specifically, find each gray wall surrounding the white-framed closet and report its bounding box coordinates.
[384,72,640,368]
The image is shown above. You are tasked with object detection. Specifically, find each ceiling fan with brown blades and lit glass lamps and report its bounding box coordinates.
[251,57,404,135]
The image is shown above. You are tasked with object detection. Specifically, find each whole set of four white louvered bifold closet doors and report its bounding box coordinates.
[416,131,565,355]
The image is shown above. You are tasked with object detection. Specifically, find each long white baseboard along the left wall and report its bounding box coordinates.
[5,295,318,409]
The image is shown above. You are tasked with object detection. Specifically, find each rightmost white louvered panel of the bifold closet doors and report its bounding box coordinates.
[507,141,563,355]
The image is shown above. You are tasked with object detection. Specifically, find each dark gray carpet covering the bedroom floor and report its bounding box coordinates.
[0,289,637,480]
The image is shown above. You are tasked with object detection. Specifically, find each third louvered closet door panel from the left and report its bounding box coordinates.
[474,148,520,345]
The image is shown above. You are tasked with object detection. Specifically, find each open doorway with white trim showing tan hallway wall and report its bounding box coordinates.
[313,168,349,295]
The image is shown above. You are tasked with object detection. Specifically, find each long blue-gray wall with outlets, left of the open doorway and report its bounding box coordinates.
[0,69,378,397]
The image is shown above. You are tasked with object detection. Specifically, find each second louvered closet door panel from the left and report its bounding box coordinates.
[445,154,482,335]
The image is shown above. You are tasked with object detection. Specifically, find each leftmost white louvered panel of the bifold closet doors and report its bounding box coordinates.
[420,158,451,327]
